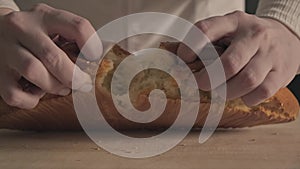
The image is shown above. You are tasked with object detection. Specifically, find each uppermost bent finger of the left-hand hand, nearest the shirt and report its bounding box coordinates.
[35,4,103,60]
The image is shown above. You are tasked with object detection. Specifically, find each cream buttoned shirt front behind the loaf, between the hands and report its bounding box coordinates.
[6,0,245,51]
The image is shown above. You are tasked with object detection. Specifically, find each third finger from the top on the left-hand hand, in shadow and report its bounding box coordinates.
[11,46,70,96]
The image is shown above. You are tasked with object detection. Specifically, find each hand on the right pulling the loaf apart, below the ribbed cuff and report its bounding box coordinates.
[178,11,300,106]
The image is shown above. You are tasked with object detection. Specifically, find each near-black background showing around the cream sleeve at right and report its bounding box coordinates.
[246,0,300,101]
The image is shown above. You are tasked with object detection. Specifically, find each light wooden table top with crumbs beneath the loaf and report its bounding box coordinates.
[0,119,300,169]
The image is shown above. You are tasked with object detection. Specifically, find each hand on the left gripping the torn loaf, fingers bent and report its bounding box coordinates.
[0,4,102,109]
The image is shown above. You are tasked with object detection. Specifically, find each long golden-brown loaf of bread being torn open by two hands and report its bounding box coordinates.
[0,42,299,131]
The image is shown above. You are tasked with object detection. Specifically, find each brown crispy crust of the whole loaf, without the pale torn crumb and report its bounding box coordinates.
[0,43,299,131]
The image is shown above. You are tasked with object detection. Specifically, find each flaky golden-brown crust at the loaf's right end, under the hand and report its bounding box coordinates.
[160,42,299,128]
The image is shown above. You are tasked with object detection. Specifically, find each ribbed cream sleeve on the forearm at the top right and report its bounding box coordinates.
[256,0,300,74]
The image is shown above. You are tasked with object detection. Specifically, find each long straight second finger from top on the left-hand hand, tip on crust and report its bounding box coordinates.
[20,31,92,90]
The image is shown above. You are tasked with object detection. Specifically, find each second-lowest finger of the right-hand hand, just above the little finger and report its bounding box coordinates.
[226,52,272,99]
